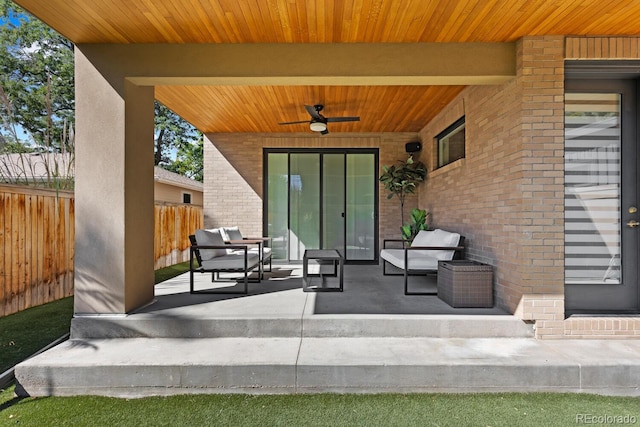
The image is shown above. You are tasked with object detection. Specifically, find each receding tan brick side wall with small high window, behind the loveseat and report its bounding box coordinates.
[420,81,523,311]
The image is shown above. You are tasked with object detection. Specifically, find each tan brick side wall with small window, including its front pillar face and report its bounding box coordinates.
[420,37,564,338]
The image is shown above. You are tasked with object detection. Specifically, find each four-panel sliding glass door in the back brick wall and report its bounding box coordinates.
[264,150,378,262]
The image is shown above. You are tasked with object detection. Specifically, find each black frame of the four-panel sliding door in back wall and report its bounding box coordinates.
[262,147,380,264]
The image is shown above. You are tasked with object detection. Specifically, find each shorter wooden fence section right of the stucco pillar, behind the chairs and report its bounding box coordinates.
[153,203,204,270]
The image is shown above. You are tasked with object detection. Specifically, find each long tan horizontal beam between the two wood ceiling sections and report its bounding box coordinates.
[78,43,516,90]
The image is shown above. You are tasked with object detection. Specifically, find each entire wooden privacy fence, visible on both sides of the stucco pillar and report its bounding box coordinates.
[0,185,203,317]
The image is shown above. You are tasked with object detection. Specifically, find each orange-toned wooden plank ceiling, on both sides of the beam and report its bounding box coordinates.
[14,0,640,133]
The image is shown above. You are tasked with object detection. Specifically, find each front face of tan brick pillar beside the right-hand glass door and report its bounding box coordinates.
[511,37,564,337]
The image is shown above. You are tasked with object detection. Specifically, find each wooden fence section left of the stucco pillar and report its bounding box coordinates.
[0,185,74,316]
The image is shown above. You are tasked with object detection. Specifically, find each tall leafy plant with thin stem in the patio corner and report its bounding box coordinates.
[380,156,427,225]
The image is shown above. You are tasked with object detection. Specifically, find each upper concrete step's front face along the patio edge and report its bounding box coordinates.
[71,313,534,339]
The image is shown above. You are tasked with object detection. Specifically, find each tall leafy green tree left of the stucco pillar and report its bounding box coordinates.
[0,0,75,151]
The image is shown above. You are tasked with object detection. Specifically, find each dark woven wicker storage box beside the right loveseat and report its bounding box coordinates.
[438,261,493,307]
